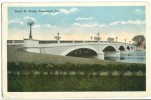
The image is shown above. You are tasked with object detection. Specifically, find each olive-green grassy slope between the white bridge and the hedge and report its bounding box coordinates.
[7,45,120,65]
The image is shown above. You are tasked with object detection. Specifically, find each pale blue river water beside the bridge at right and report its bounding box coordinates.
[105,50,146,64]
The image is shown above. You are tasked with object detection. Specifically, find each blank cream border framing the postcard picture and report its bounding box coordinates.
[2,2,151,99]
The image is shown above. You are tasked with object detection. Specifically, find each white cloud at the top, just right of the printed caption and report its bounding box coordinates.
[50,8,78,16]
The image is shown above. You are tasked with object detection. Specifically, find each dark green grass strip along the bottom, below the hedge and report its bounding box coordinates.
[8,75,146,92]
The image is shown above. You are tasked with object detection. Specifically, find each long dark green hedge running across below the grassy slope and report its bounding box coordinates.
[7,62,146,75]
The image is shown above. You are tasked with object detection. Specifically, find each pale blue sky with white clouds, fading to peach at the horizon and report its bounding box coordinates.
[8,6,146,42]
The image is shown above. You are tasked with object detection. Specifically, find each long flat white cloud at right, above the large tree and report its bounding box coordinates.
[109,20,146,26]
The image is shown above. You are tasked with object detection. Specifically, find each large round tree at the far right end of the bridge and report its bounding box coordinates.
[132,35,146,47]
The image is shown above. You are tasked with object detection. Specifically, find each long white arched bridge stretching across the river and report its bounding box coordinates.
[23,39,136,59]
